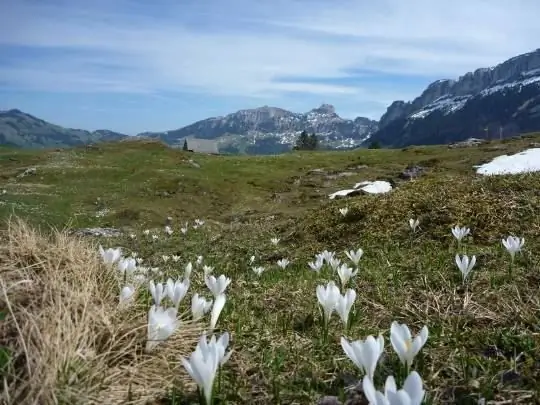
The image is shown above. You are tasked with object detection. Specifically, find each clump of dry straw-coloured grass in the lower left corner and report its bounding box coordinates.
[0,219,200,405]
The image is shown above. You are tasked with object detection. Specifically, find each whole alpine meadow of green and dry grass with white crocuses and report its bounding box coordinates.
[0,134,540,405]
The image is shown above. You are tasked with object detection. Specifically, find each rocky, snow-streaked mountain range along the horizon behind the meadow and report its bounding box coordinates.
[0,49,540,154]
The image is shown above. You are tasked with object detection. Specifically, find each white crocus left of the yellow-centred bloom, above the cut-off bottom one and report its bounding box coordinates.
[341,335,384,380]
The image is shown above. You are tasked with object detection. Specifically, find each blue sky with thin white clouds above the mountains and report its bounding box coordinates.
[0,0,540,134]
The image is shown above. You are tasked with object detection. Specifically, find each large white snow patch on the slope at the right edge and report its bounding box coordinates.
[475,148,540,176]
